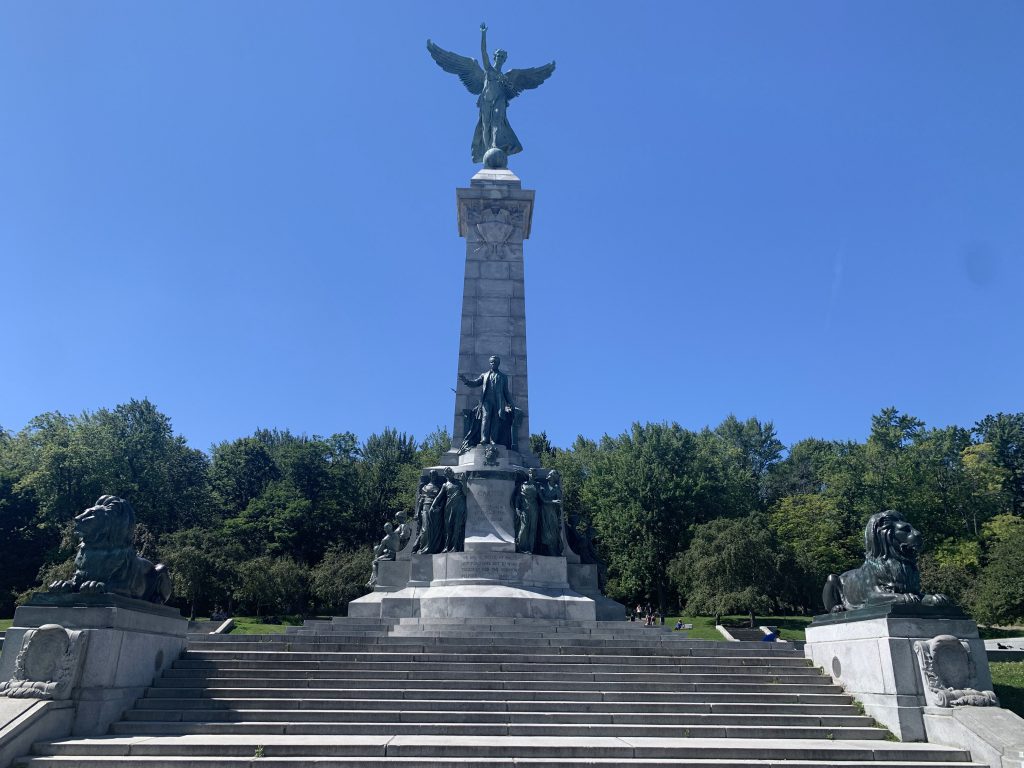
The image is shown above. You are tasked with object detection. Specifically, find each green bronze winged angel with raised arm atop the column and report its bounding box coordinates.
[427,24,555,168]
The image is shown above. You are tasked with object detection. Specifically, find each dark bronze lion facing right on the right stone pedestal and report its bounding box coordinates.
[821,509,949,613]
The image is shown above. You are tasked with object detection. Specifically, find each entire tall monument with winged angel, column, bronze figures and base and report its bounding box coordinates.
[348,25,625,621]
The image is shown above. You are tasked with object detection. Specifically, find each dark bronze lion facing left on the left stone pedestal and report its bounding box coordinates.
[50,496,171,603]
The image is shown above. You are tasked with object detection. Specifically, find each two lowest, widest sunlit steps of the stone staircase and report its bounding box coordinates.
[23,734,970,768]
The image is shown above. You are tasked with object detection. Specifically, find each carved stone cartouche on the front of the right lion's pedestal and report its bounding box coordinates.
[913,635,999,707]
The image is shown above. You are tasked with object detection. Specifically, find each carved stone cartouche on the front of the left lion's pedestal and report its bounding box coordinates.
[0,624,89,699]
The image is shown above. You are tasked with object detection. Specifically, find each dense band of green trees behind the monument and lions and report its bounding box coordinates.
[0,400,1024,623]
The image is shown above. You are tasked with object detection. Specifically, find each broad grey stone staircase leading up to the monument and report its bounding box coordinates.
[17,618,975,768]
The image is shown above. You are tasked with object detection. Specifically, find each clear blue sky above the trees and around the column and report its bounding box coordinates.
[0,0,1024,450]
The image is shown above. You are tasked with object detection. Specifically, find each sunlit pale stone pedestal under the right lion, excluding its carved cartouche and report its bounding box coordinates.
[805,605,992,741]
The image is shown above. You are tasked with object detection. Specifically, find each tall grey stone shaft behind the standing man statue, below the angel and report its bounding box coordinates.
[452,169,537,465]
